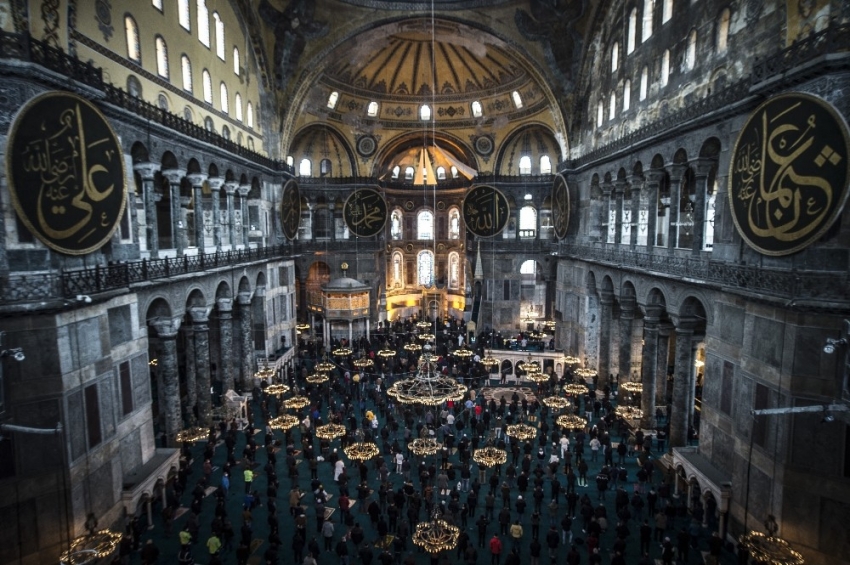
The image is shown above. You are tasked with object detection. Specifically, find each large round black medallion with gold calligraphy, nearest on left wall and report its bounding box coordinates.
[6,92,127,255]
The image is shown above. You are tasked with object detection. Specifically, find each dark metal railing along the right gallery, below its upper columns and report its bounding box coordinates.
[558,243,850,301]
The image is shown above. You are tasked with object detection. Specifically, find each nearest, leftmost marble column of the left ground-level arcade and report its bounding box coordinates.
[150,318,183,446]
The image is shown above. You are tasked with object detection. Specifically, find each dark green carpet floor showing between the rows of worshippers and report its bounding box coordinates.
[124,381,737,565]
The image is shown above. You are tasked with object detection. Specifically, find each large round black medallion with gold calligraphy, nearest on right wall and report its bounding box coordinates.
[729,93,850,255]
